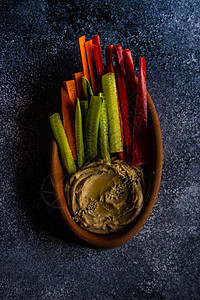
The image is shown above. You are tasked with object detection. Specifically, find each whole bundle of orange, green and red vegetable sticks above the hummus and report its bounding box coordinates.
[50,35,149,174]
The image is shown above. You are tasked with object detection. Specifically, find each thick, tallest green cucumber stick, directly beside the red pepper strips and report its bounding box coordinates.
[102,73,123,153]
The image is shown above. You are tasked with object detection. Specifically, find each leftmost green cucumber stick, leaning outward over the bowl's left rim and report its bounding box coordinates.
[50,113,76,174]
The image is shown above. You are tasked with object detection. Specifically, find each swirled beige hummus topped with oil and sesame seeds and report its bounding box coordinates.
[65,159,144,234]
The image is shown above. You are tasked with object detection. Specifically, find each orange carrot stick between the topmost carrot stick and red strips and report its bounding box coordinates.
[85,40,98,95]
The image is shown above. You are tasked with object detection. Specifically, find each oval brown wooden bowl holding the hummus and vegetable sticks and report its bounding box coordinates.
[50,93,163,249]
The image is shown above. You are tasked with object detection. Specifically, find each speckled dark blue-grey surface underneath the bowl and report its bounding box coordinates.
[0,0,200,299]
